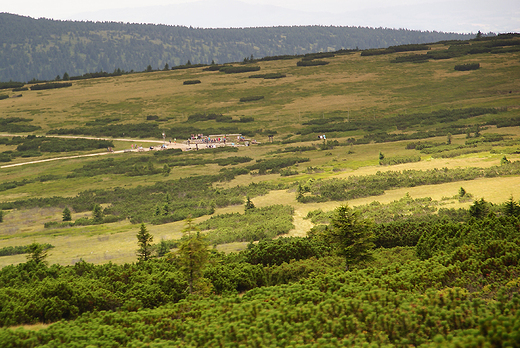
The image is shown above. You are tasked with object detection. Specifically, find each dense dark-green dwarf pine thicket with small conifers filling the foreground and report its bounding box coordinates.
[0,198,520,347]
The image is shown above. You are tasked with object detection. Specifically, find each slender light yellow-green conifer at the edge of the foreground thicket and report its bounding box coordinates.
[177,217,209,294]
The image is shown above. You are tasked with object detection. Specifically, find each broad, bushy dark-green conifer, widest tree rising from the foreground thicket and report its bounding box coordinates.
[325,205,375,269]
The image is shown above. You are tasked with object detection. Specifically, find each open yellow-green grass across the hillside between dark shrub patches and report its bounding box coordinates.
[0,40,520,267]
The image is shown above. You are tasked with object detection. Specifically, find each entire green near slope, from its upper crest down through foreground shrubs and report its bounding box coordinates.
[0,34,520,347]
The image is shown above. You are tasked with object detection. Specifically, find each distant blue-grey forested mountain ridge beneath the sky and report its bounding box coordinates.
[0,13,474,82]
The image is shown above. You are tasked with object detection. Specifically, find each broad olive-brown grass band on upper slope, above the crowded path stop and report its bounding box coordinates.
[4,46,520,137]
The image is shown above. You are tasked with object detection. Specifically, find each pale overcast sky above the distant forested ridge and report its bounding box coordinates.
[4,0,520,33]
